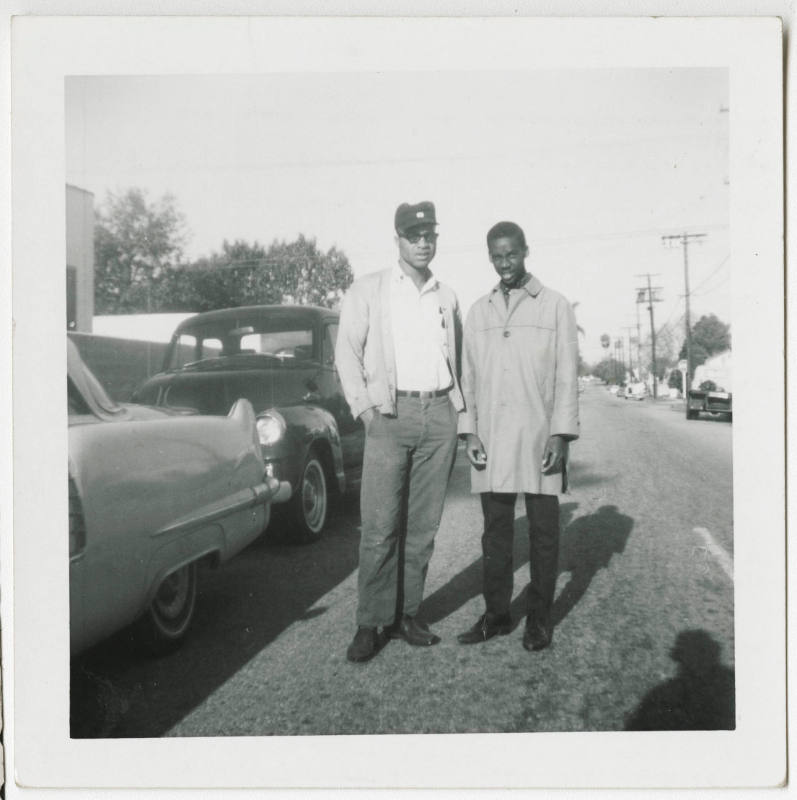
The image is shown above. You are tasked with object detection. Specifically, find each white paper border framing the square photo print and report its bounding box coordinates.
[4,17,786,789]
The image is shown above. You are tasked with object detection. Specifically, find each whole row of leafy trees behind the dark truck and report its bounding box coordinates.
[94,188,353,314]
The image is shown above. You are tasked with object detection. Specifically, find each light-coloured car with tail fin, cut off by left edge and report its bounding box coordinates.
[67,341,278,655]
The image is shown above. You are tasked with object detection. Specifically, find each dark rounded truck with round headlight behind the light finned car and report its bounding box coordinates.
[133,305,365,540]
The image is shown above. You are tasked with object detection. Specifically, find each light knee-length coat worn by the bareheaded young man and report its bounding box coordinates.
[458,276,579,494]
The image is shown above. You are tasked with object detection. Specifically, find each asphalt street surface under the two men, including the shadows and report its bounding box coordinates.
[72,387,734,737]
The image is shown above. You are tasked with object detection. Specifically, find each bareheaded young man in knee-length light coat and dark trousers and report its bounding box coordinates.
[457,222,579,650]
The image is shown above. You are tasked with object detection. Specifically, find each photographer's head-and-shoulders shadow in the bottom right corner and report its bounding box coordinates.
[625,630,736,731]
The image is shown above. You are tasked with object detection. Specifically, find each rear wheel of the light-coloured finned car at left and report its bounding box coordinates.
[140,562,197,653]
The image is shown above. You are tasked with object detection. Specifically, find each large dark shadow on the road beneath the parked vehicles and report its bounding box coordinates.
[70,499,360,738]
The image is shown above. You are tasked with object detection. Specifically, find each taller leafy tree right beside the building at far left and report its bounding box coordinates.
[94,188,185,314]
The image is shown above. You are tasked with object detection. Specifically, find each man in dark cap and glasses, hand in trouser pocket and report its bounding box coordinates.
[335,202,464,661]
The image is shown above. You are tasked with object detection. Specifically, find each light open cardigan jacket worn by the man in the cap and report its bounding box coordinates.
[335,269,465,417]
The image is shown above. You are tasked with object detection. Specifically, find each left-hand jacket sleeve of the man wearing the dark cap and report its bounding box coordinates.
[335,283,375,417]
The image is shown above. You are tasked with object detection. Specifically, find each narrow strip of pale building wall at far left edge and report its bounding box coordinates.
[66,184,94,333]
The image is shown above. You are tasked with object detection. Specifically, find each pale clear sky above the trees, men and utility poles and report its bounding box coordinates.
[66,69,732,361]
